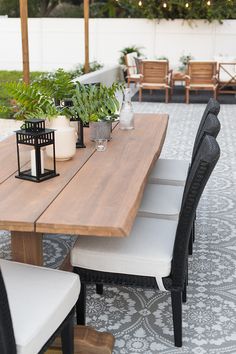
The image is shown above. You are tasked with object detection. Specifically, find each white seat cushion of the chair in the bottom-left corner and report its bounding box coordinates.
[0,260,80,354]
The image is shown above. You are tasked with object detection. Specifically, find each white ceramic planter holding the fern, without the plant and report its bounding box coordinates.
[46,116,76,161]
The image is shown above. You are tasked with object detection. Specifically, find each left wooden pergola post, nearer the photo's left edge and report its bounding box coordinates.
[20,0,30,84]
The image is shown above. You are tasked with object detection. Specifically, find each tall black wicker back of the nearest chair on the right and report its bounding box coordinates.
[171,135,220,289]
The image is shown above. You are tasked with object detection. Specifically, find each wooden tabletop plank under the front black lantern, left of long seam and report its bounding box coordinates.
[0,129,95,232]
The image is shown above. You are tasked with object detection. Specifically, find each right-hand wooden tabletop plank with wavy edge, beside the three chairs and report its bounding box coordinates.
[36,114,168,236]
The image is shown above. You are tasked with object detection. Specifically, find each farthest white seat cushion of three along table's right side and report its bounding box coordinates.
[148,159,190,186]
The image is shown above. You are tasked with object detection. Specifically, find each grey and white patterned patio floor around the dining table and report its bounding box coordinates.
[0,102,236,354]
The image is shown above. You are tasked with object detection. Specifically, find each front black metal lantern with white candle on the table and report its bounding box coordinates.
[16,119,59,182]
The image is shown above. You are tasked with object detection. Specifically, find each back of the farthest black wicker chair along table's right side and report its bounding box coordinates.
[192,98,220,161]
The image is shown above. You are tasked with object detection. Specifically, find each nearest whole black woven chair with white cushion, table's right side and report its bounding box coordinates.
[71,136,220,347]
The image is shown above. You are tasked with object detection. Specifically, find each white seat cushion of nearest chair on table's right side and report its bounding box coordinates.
[71,217,177,278]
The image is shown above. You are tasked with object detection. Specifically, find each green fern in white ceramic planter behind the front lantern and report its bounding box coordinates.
[2,69,76,160]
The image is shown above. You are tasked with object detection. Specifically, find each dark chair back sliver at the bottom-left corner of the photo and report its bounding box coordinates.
[0,269,16,354]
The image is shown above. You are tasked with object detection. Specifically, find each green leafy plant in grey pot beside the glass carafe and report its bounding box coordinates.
[70,82,124,140]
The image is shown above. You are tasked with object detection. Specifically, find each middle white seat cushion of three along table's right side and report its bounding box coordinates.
[138,184,184,220]
